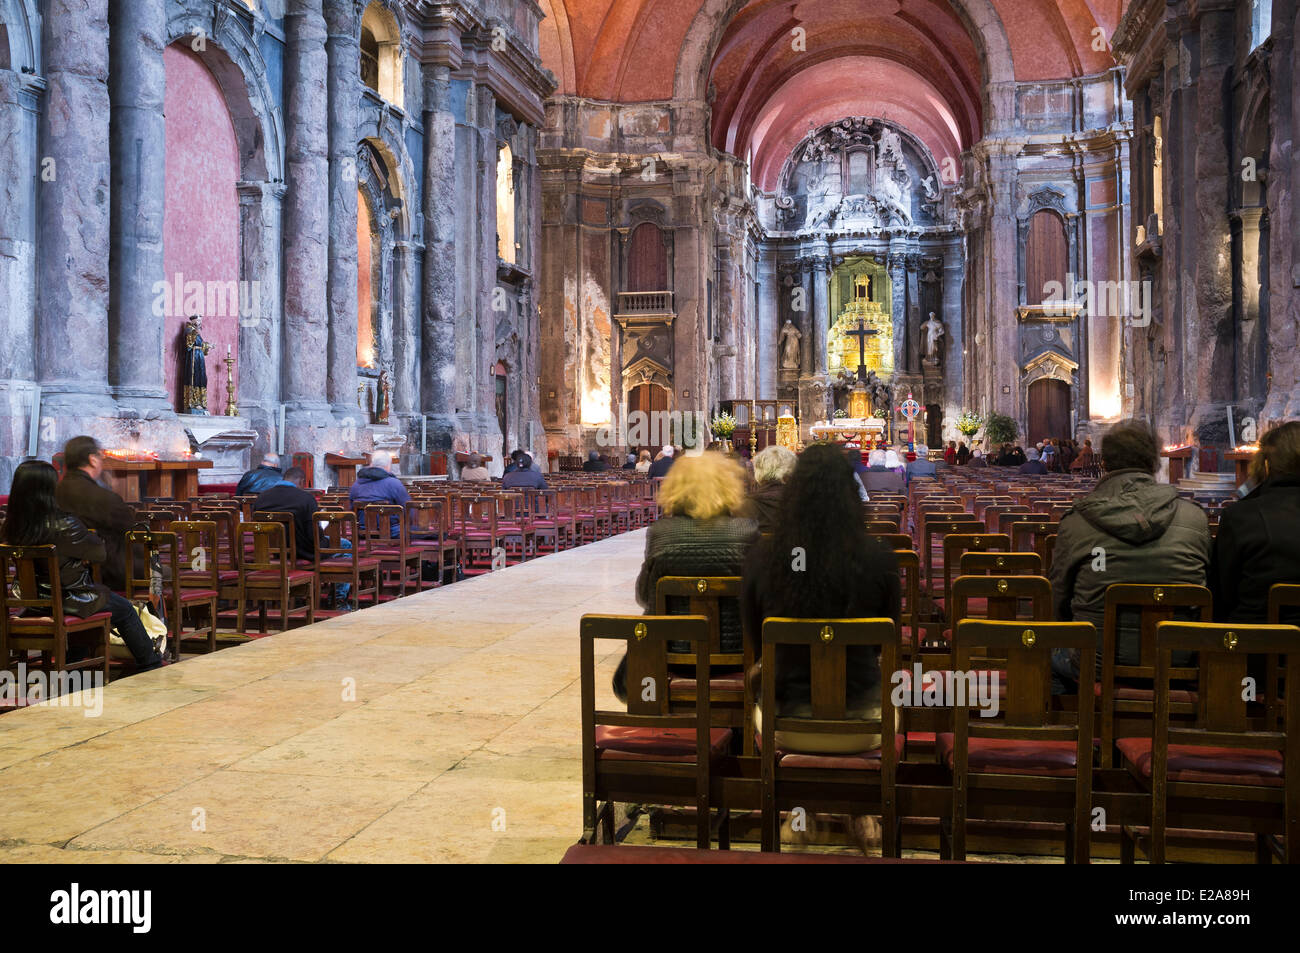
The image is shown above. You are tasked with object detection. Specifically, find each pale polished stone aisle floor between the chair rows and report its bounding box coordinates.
[0,530,645,863]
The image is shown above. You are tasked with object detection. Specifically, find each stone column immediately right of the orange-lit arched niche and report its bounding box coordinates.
[420,65,456,421]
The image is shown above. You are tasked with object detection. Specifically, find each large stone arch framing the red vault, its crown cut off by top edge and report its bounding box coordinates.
[672,0,1015,133]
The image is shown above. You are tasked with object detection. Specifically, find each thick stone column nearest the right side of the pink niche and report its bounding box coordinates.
[283,0,332,426]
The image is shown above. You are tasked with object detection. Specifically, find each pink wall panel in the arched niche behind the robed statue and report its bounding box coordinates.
[163,43,241,415]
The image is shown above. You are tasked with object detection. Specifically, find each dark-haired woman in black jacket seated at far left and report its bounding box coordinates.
[3,460,163,672]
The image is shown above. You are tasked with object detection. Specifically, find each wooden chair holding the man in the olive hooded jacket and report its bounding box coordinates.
[1102,582,1214,768]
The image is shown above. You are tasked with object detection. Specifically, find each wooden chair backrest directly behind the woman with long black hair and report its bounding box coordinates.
[761,619,898,769]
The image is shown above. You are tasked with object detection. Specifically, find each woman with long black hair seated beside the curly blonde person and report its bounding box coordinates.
[742,443,901,849]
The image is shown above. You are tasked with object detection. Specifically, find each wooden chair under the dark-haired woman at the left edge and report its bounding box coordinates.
[0,545,112,685]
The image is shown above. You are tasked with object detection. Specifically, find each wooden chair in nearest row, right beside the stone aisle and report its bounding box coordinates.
[580,615,732,849]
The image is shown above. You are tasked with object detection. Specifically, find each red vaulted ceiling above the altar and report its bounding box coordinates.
[540,0,1126,189]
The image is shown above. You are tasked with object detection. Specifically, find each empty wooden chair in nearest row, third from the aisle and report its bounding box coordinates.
[936,620,1097,863]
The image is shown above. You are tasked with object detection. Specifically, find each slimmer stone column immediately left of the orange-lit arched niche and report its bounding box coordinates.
[325,0,361,419]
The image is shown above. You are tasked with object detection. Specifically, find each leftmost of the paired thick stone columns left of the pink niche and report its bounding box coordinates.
[37,0,117,426]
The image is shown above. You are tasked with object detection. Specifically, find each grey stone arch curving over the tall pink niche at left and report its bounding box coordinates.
[166,6,285,183]
